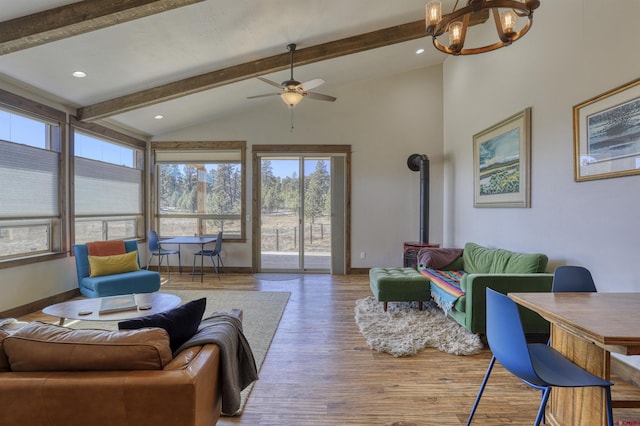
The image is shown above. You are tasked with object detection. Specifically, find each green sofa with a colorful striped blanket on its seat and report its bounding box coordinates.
[418,242,553,334]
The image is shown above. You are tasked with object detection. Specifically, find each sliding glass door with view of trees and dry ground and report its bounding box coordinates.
[259,155,332,272]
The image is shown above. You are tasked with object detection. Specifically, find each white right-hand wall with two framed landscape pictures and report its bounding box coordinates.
[443,0,640,366]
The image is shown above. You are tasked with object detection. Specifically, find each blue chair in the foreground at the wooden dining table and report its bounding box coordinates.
[467,288,613,426]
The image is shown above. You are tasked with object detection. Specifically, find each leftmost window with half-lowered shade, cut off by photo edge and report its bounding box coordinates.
[0,97,65,267]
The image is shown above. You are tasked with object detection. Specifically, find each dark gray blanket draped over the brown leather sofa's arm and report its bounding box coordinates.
[174,312,258,415]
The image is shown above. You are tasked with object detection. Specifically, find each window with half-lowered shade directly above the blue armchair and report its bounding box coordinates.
[73,122,144,243]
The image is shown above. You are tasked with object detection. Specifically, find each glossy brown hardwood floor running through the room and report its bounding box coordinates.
[24,274,640,426]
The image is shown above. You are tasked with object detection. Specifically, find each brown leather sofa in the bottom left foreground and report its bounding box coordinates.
[0,323,221,426]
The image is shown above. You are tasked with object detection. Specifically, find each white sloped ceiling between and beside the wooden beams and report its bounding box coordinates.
[0,0,446,136]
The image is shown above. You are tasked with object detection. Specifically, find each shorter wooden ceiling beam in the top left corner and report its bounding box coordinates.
[0,0,204,55]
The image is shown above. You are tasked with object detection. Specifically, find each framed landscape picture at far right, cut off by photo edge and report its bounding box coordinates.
[573,79,640,182]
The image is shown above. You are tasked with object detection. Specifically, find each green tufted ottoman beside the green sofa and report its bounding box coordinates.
[369,268,431,312]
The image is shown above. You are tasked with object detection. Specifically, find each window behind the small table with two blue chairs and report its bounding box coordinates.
[152,142,245,240]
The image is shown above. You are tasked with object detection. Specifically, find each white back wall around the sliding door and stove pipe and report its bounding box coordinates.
[154,66,442,268]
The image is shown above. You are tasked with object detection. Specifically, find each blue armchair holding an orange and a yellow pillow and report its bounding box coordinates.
[73,240,160,298]
